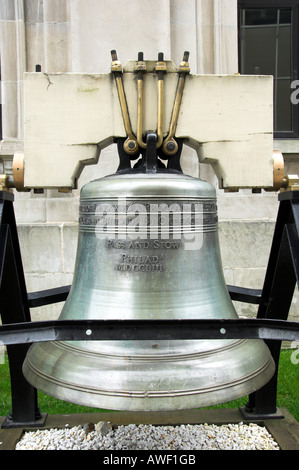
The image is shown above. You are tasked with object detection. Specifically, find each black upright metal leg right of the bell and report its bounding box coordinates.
[243,191,299,418]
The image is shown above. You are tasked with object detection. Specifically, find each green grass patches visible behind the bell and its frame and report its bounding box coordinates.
[0,350,299,422]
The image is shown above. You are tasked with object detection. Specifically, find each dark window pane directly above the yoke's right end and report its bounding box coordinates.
[241,26,276,75]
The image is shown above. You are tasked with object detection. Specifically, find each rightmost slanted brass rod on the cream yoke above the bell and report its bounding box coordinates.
[163,51,190,155]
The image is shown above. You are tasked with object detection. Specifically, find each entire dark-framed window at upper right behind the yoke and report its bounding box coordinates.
[239,0,299,138]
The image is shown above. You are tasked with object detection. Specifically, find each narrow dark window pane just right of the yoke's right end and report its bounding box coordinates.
[275,80,292,131]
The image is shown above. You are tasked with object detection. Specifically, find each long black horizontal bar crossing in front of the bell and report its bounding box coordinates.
[0,319,299,345]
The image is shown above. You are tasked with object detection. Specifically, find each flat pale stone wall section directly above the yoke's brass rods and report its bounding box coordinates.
[71,0,171,73]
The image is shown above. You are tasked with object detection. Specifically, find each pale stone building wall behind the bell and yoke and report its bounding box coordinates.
[0,0,299,326]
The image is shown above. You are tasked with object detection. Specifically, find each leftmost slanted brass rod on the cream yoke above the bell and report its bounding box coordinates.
[111,50,139,155]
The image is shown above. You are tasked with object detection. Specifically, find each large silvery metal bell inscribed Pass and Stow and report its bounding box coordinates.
[23,153,275,411]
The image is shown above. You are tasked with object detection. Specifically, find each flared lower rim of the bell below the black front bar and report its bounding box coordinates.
[23,340,275,411]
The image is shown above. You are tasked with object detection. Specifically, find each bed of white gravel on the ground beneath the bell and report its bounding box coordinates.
[14,421,279,451]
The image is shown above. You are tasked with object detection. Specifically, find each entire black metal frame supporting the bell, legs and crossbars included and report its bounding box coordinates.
[0,186,299,428]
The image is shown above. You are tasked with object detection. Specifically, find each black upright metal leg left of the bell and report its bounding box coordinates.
[0,191,45,427]
